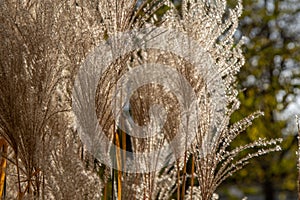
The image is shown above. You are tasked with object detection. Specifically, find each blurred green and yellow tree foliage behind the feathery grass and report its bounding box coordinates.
[232,0,300,200]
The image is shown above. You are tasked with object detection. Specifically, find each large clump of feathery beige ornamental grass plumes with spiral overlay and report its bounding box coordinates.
[0,0,281,200]
